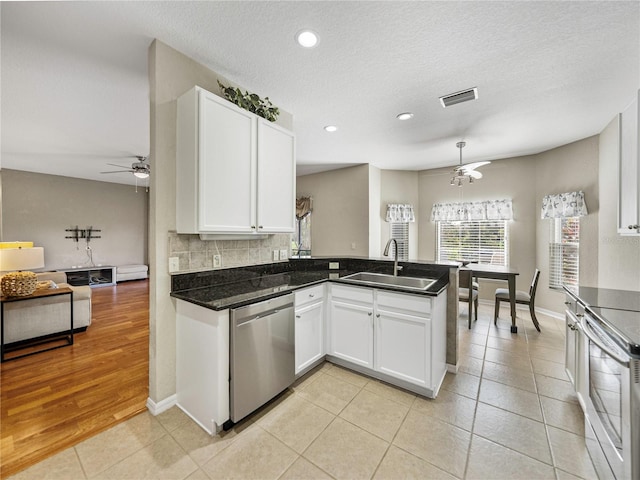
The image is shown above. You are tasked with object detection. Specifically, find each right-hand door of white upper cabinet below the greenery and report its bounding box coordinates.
[257,119,296,233]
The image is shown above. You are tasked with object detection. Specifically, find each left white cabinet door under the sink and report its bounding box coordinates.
[329,301,373,368]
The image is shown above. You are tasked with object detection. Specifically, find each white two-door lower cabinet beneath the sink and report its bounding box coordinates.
[327,284,446,397]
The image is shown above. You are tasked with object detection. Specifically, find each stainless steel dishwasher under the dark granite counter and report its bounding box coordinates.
[229,294,295,422]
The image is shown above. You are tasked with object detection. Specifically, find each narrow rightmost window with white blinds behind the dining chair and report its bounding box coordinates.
[549,217,580,288]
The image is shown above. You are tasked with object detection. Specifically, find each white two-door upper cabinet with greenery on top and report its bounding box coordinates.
[176,87,295,235]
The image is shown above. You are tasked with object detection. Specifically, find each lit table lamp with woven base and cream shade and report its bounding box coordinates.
[0,248,44,297]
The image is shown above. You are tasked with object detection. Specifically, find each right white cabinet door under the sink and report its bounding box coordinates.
[375,308,431,388]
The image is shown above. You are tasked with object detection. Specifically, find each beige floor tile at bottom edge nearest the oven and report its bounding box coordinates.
[547,426,598,479]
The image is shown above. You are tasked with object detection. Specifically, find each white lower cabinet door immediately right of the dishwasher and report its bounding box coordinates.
[295,299,324,375]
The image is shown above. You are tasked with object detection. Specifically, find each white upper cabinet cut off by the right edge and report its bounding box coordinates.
[618,91,640,235]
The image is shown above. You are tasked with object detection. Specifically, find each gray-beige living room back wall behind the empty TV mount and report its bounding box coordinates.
[2,169,149,269]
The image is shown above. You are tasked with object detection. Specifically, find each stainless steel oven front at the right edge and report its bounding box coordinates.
[580,311,640,480]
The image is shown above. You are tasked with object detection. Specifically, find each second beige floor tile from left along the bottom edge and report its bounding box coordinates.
[95,436,198,480]
